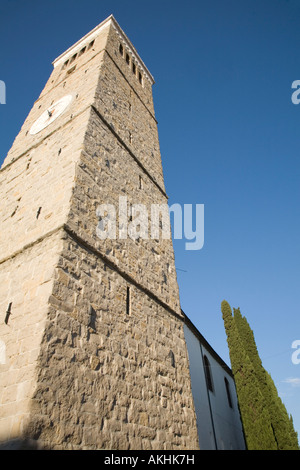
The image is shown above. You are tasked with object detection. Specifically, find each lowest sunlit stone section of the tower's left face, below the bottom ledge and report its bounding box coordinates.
[0,232,62,442]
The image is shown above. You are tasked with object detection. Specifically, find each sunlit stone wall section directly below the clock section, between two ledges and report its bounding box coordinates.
[0,111,89,261]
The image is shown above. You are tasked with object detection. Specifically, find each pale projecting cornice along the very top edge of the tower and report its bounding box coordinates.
[52,15,155,85]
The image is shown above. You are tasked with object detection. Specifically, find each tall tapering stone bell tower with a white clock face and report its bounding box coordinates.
[0,16,198,450]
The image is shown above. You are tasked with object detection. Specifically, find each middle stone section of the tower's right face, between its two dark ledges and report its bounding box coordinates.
[68,110,181,315]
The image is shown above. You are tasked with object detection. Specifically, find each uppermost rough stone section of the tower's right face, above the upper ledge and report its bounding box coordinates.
[94,23,165,191]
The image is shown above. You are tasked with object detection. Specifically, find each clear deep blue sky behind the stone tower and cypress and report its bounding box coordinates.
[0,0,300,435]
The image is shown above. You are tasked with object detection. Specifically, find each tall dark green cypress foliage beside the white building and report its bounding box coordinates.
[221,301,299,450]
